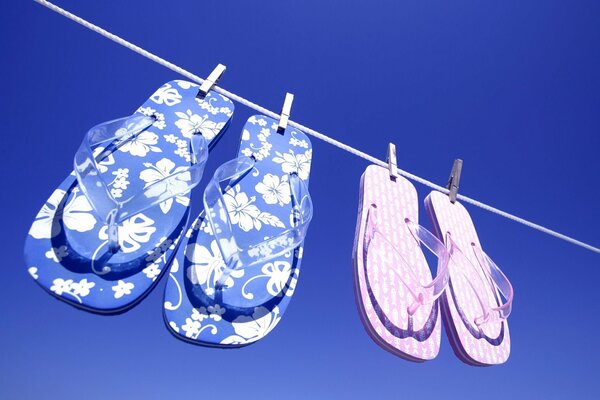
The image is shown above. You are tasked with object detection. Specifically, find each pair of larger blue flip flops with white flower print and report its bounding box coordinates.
[25,81,312,347]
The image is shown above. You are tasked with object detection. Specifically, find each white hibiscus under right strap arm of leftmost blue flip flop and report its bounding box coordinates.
[140,158,192,214]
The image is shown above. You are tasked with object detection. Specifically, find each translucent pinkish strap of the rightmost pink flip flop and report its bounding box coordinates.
[446,234,514,326]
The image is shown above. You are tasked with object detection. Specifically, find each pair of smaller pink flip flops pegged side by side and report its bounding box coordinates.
[353,165,513,366]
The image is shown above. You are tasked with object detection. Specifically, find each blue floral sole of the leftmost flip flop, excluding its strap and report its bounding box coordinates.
[25,81,233,314]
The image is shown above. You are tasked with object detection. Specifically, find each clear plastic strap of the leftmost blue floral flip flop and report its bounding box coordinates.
[73,115,208,252]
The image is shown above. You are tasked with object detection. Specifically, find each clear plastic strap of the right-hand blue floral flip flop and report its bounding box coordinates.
[204,157,313,286]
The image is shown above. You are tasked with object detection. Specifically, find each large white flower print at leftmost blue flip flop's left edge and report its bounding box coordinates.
[29,189,96,239]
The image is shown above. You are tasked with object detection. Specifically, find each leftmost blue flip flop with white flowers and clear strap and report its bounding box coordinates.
[25,81,234,313]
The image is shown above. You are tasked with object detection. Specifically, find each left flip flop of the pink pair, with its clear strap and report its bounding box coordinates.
[353,165,449,362]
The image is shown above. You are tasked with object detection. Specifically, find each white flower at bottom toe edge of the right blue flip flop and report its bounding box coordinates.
[221,307,281,344]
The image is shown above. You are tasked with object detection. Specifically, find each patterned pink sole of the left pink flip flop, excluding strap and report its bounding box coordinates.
[353,165,441,362]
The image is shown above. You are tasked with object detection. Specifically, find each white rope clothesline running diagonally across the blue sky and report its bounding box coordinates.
[34,0,600,254]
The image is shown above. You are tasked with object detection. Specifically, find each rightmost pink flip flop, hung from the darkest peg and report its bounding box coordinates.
[425,191,513,366]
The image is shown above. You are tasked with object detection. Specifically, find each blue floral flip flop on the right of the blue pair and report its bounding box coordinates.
[164,115,312,347]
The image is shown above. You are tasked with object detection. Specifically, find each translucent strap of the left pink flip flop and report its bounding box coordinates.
[363,204,450,315]
